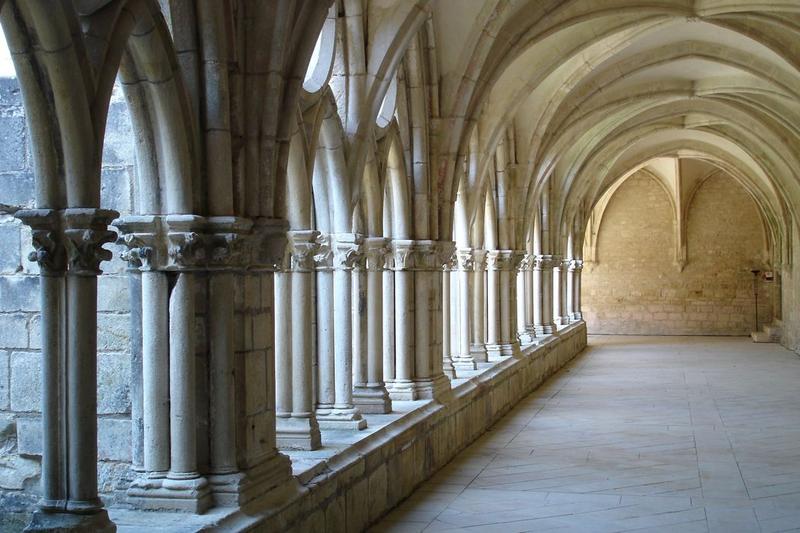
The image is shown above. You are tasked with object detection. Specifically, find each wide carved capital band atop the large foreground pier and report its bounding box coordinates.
[112,215,288,272]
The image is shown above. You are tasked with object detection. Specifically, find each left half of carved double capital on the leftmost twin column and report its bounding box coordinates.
[15,209,67,276]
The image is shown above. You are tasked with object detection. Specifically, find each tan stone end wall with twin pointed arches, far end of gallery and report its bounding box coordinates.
[583,173,774,335]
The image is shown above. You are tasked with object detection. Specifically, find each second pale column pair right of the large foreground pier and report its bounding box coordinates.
[317,233,367,429]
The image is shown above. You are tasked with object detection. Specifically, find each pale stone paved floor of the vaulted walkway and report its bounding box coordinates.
[373,337,800,533]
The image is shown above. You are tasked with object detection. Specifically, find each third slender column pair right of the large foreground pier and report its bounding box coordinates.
[353,237,392,414]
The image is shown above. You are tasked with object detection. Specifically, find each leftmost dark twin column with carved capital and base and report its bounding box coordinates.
[16,208,117,531]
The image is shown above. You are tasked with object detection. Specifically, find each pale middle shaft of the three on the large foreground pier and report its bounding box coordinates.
[169,272,199,479]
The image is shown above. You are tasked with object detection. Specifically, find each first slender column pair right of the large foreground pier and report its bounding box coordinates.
[275,230,322,450]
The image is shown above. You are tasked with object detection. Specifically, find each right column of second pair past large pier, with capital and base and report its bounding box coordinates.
[317,233,367,429]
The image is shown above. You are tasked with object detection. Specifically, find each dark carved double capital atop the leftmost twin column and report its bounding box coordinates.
[15,208,119,276]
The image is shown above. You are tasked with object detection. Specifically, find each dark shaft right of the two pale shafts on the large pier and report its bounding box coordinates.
[208,273,237,474]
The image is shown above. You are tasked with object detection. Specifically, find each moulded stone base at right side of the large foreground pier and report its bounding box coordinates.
[208,453,292,507]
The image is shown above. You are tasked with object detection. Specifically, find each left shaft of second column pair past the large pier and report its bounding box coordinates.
[317,270,334,413]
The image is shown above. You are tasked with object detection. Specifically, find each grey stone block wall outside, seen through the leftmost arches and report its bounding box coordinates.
[0,78,134,502]
